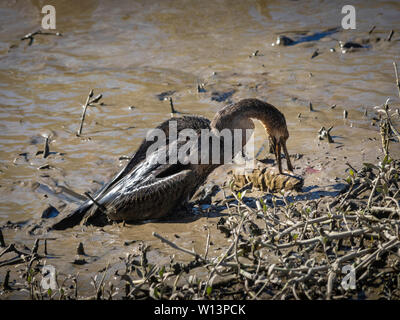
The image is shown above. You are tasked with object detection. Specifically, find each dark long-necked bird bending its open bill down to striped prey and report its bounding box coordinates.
[52,99,293,229]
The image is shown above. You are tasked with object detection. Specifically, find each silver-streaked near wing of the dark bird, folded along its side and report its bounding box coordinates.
[84,140,200,224]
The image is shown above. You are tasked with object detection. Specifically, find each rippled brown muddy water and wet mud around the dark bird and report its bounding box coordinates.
[0,0,400,298]
